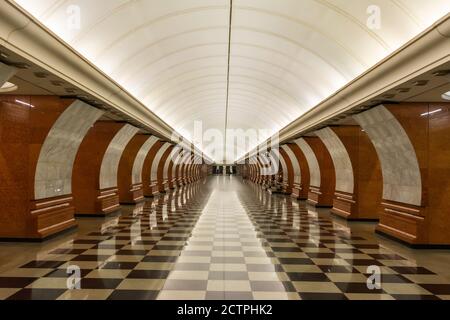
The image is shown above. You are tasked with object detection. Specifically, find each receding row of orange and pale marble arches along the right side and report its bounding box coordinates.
[240,102,450,246]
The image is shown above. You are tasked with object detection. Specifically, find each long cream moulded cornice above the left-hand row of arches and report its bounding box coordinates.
[0,0,182,141]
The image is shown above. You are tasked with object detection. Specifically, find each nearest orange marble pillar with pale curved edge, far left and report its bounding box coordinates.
[0,95,103,240]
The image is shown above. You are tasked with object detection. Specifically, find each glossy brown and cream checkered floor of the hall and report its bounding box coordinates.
[0,177,450,300]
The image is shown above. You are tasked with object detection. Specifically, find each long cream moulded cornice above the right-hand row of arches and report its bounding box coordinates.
[237,14,450,162]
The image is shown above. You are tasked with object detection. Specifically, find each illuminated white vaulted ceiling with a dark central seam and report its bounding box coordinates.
[16,0,450,161]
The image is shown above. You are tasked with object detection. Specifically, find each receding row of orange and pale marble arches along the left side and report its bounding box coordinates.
[0,95,207,239]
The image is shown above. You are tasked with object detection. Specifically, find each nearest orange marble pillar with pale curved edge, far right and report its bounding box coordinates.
[354,103,450,246]
